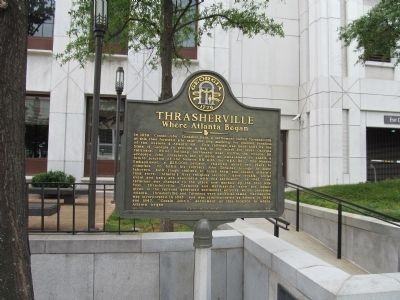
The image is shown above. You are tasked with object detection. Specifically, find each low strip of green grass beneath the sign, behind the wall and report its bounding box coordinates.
[105,212,192,232]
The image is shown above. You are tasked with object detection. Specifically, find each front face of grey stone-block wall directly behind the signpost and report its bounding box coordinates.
[30,231,243,300]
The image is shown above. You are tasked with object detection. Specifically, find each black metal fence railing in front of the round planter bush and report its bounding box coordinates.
[26,183,137,234]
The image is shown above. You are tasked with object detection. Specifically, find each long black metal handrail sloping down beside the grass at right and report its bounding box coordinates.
[286,182,400,259]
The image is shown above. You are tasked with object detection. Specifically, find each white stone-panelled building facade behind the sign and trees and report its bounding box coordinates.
[26,0,400,186]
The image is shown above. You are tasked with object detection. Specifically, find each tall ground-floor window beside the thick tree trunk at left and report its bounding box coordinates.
[25,95,50,175]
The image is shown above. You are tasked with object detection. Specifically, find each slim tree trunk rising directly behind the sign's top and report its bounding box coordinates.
[160,0,174,100]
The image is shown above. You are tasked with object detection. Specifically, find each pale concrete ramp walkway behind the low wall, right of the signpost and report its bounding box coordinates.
[230,218,368,275]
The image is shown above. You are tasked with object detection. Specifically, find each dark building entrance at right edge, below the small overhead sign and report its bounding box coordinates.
[367,128,400,181]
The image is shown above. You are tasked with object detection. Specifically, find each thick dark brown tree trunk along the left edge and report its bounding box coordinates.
[0,0,33,299]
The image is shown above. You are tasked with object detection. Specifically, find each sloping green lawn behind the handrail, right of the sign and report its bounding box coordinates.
[285,179,400,220]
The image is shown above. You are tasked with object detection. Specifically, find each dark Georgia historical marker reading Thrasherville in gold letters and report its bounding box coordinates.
[117,71,283,221]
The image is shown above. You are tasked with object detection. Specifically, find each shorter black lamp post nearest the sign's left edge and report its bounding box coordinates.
[114,67,124,201]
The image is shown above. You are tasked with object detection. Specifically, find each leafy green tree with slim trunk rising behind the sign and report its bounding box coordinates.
[57,0,283,100]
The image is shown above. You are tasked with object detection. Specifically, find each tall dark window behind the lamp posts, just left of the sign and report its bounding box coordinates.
[85,96,125,176]
